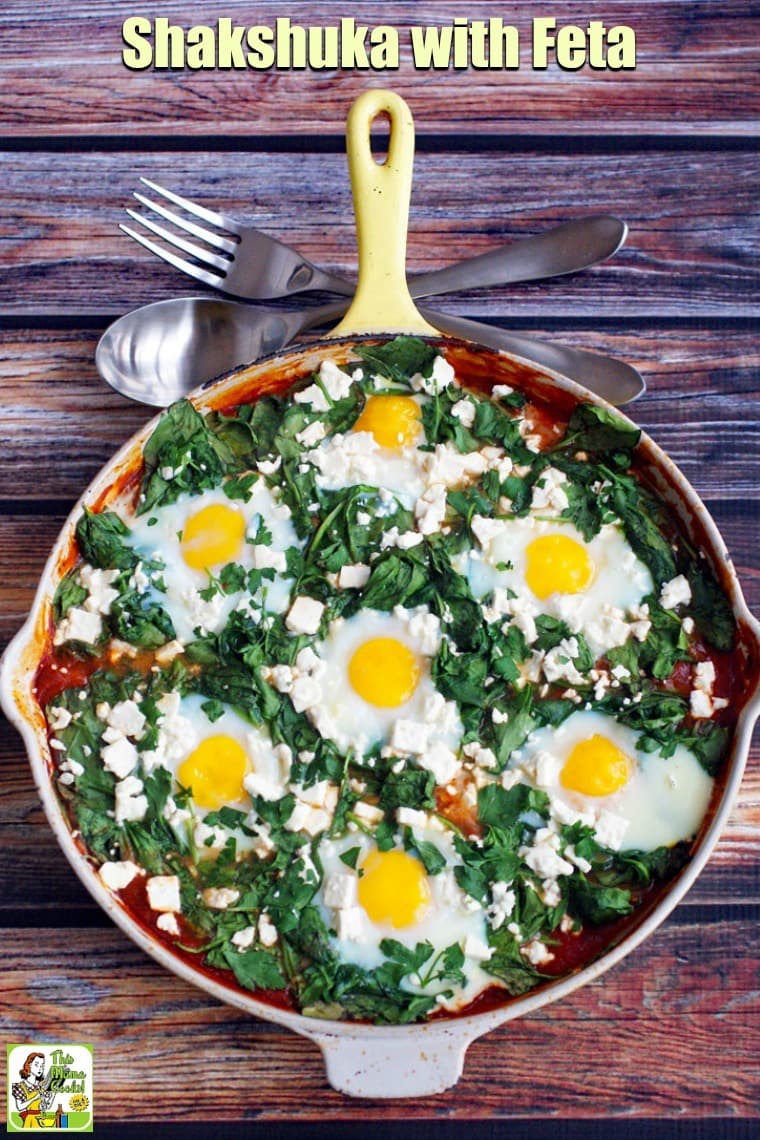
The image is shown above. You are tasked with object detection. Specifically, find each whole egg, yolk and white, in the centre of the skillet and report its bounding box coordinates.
[314,610,463,755]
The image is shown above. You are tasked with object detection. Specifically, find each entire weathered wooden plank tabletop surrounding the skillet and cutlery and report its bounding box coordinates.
[0,0,760,1140]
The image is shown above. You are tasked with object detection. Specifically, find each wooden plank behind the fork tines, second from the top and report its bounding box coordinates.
[0,147,760,318]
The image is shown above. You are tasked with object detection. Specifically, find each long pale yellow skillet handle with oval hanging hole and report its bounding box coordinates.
[329,90,439,336]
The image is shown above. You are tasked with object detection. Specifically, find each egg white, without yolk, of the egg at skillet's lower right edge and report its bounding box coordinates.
[510,710,713,852]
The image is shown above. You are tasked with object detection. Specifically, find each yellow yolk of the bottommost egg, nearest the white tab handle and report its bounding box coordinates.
[359,849,431,929]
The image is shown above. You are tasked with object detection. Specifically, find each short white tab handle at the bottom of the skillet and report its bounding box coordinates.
[309,1026,472,1100]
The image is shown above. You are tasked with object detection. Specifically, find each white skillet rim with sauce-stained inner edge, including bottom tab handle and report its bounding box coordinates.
[0,336,760,1098]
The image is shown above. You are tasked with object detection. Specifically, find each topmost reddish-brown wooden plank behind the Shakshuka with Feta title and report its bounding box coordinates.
[0,0,758,138]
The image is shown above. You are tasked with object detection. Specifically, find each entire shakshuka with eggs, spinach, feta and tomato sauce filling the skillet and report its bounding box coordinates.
[34,337,741,1024]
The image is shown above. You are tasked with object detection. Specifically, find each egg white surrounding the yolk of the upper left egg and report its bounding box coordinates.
[125,479,300,642]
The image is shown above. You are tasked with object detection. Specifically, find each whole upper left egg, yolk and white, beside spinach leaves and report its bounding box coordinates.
[130,479,299,642]
